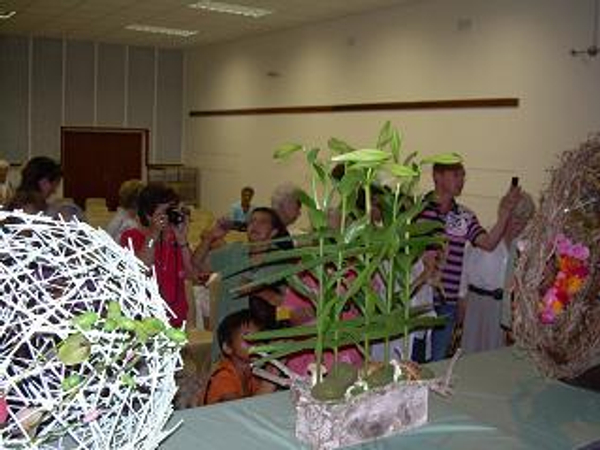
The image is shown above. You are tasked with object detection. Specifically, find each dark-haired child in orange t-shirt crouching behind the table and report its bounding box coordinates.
[198,309,275,405]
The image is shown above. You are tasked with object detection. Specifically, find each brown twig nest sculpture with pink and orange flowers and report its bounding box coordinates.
[514,135,600,378]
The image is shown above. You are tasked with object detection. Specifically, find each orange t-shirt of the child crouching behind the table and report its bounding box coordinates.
[199,358,259,405]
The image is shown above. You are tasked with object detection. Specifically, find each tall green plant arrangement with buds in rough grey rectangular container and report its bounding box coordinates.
[234,122,454,448]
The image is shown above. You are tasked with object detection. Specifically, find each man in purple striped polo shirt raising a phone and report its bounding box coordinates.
[420,158,520,361]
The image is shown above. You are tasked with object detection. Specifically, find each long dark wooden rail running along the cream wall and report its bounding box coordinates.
[190,97,519,117]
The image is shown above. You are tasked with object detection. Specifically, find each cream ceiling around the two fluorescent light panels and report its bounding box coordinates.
[0,0,417,47]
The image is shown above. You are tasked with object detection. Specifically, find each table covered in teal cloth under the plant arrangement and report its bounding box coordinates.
[161,347,600,450]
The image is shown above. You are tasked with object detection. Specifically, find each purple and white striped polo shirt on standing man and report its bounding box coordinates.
[419,193,485,303]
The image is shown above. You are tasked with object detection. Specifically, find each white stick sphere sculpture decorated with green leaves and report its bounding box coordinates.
[0,211,185,449]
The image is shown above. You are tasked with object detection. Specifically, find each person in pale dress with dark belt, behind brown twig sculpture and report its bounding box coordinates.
[459,192,535,353]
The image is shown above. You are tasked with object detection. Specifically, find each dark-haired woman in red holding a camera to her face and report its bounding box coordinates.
[121,183,194,327]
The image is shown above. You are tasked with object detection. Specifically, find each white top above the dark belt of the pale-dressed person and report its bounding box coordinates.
[459,240,508,297]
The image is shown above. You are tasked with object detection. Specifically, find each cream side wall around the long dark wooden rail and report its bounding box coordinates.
[184,0,600,224]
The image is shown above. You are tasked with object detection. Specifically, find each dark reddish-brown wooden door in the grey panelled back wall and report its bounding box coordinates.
[61,127,148,210]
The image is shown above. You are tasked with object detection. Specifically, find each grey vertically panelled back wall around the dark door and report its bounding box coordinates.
[0,35,183,163]
